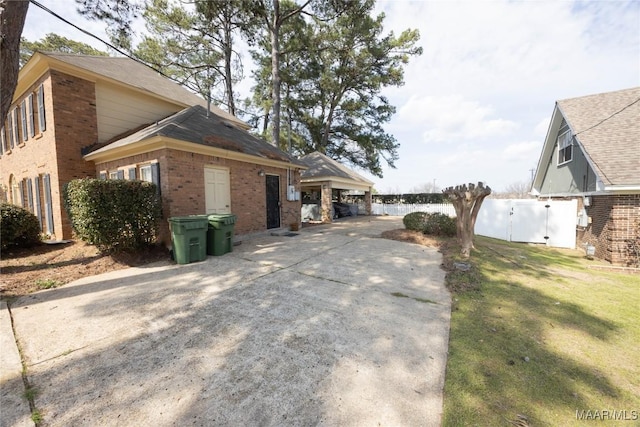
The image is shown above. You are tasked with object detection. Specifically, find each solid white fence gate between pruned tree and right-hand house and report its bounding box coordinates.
[475,199,578,249]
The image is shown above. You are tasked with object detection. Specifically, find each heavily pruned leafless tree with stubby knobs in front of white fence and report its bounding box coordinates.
[443,182,491,258]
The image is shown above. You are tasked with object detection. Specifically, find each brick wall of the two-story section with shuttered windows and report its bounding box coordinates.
[0,70,97,239]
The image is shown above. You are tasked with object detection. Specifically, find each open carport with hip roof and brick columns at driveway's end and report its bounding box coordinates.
[300,151,373,222]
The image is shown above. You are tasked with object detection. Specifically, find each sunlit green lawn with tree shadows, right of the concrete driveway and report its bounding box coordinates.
[443,237,640,426]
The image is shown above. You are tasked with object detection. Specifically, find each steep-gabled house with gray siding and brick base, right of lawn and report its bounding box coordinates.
[533,87,640,266]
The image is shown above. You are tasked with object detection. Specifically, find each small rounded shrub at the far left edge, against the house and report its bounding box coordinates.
[0,203,40,249]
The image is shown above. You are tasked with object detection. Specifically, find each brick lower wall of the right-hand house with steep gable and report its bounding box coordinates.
[578,194,640,266]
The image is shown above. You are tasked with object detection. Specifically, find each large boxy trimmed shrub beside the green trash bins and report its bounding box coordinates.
[63,178,162,252]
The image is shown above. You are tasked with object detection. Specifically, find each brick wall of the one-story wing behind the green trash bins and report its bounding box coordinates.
[95,149,301,244]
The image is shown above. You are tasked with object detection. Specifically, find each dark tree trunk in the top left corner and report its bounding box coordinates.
[0,0,29,123]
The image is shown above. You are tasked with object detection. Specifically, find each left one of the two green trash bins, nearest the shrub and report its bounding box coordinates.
[169,215,207,264]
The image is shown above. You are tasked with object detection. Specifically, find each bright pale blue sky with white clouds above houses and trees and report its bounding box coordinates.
[23,0,640,193]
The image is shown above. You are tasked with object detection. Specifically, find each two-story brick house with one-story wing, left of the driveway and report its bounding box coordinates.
[0,52,305,243]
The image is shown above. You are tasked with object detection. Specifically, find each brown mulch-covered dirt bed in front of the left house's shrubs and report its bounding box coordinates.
[0,241,170,299]
